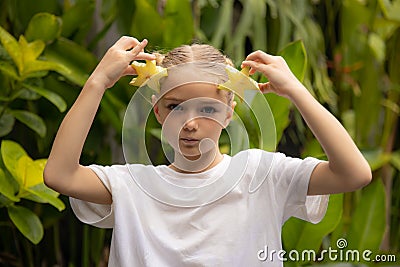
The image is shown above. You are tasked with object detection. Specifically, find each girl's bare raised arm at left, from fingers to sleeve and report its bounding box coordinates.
[44,36,154,204]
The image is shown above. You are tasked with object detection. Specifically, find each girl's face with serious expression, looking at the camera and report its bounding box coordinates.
[154,83,235,160]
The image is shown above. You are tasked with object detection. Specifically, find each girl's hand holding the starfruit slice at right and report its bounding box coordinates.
[242,50,304,99]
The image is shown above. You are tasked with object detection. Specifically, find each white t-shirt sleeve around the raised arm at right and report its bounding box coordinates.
[271,153,329,223]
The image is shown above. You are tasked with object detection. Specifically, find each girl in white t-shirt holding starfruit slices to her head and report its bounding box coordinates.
[44,37,371,266]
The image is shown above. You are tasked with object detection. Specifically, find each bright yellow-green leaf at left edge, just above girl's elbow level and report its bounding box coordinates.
[0,140,27,183]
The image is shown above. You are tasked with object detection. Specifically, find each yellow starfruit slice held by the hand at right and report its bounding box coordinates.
[218,66,259,100]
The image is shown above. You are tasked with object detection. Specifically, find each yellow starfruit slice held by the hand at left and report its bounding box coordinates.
[129,60,168,91]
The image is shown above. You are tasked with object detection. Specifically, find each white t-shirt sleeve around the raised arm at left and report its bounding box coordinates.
[69,165,114,228]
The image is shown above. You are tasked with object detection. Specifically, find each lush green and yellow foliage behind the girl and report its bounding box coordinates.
[0,0,400,266]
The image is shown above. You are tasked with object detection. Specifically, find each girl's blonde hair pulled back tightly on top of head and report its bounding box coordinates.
[153,44,234,102]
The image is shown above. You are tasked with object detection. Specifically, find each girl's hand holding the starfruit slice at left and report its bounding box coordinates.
[88,36,155,89]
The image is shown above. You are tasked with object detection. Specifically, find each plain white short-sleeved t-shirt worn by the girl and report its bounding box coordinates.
[70,149,329,267]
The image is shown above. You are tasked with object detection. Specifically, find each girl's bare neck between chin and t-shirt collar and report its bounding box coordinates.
[169,148,223,173]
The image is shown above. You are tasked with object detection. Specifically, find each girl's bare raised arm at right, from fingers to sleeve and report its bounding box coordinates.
[242,51,372,195]
